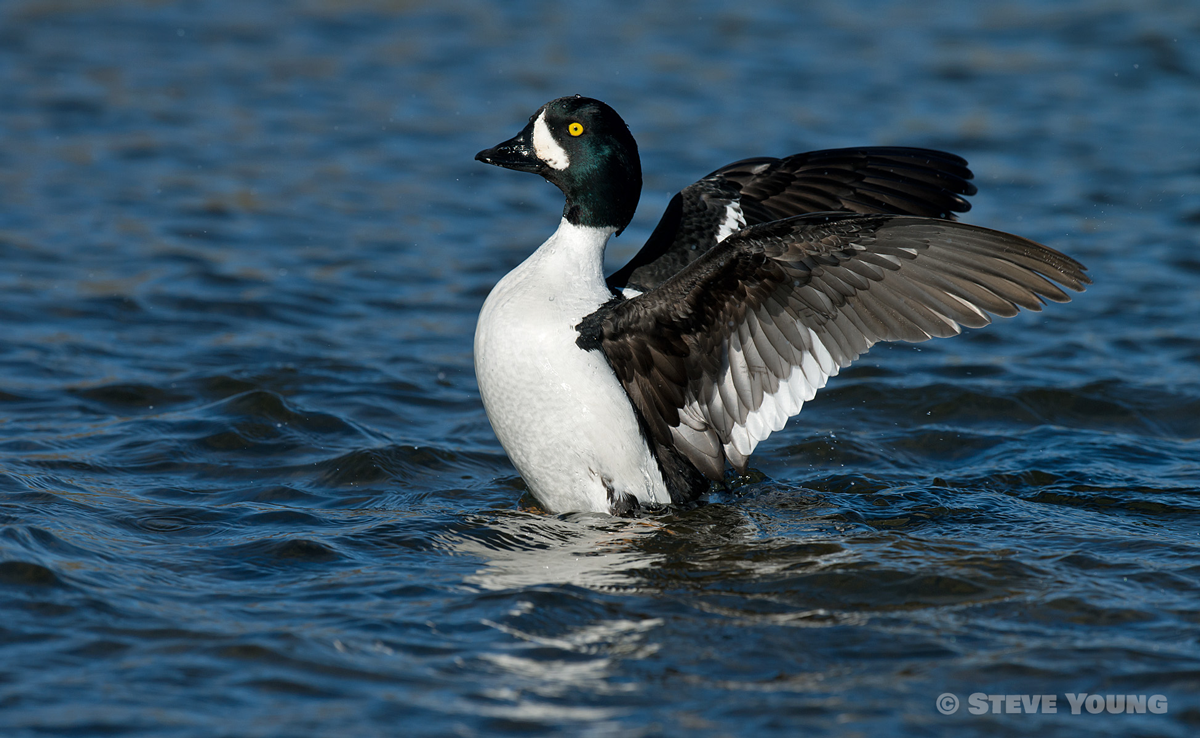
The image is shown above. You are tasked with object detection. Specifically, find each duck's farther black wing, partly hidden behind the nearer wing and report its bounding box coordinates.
[608,146,976,292]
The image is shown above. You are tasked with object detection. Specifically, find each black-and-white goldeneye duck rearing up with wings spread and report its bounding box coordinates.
[475,96,1091,515]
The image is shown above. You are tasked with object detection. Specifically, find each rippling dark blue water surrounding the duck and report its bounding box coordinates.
[0,0,1200,738]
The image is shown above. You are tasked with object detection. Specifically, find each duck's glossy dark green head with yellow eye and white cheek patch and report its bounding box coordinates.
[475,95,642,234]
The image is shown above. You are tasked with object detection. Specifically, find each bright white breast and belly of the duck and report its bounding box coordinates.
[475,220,671,512]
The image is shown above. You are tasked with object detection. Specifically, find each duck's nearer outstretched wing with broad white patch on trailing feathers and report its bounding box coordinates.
[590,214,1091,480]
